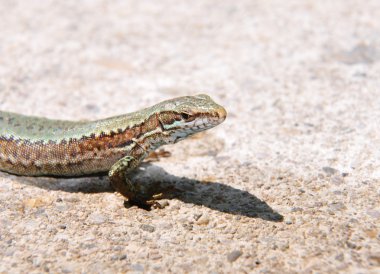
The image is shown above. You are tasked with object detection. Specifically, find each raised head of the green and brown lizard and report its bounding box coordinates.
[157,94,227,143]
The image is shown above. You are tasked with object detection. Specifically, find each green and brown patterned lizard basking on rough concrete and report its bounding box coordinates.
[0,94,227,207]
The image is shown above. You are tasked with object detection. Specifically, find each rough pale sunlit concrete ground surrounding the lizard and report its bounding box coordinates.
[0,0,380,273]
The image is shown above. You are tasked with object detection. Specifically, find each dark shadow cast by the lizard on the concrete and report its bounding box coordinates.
[14,163,283,222]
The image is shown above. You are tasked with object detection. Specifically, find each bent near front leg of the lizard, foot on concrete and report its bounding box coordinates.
[108,156,163,208]
